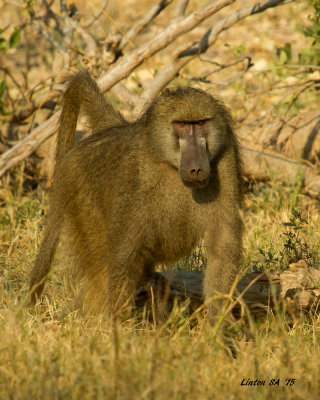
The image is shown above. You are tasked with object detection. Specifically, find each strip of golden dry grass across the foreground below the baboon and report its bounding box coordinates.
[0,309,320,399]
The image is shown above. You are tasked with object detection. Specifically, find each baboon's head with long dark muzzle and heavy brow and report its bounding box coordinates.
[147,87,233,188]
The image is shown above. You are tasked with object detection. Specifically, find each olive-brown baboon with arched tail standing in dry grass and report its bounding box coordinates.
[30,70,243,321]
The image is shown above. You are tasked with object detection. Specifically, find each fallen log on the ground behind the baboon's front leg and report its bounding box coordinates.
[136,260,320,316]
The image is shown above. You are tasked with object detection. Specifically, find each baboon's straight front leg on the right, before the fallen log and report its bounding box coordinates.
[203,214,242,324]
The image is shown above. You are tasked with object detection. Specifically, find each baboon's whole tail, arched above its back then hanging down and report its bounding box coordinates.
[30,70,125,304]
